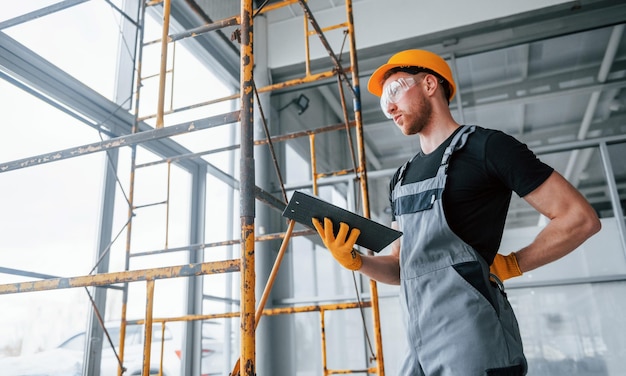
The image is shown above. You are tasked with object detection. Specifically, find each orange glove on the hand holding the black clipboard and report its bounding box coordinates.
[312,218,363,270]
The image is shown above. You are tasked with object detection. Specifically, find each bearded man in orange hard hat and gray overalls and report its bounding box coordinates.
[313,50,600,376]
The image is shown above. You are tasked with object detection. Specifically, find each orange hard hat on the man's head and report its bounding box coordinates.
[367,50,456,101]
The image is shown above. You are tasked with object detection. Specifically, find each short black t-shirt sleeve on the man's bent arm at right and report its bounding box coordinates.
[485,131,554,197]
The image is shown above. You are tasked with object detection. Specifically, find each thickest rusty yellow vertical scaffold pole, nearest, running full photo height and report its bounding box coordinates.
[239,0,256,376]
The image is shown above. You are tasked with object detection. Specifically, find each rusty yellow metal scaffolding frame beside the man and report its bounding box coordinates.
[0,0,384,376]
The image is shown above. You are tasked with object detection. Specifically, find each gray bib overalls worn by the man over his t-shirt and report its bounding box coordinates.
[392,126,527,376]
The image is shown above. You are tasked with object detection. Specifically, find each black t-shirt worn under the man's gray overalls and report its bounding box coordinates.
[389,126,553,264]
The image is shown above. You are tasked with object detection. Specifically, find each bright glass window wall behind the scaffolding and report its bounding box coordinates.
[0,1,238,375]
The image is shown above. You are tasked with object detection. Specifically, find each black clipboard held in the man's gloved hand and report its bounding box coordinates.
[283,191,402,253]
